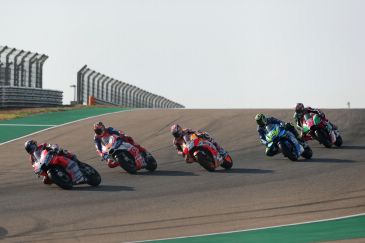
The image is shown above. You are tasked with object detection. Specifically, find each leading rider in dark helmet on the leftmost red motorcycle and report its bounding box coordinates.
[24,140,84,185]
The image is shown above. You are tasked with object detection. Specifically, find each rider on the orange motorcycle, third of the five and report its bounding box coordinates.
[171,124,228,163]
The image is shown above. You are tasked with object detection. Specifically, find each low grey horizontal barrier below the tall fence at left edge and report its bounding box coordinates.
[0,86,63,108]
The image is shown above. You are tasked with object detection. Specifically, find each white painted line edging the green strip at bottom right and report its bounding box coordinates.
[126,213,365,243]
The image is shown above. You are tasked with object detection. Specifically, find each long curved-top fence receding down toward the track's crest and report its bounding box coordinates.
[77,65,184,108]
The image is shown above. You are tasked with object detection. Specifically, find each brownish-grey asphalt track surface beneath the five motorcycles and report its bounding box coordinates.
[0,109,365,242]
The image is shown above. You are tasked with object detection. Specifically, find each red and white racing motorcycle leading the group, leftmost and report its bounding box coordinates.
[32,150,101,190]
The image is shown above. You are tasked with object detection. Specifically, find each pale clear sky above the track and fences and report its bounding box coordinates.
[0,0,365,109]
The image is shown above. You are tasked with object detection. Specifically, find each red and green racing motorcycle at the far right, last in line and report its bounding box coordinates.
[302,113,342,148]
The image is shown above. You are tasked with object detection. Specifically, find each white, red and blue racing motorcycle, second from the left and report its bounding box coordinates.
[103,135,157,174]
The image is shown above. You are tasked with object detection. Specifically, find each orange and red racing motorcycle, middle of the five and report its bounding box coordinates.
[182,134,233,171]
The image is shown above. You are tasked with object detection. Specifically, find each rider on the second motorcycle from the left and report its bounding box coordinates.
[94,121,147,168]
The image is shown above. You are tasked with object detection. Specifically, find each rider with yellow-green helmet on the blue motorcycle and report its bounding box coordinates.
[255,114,308,156]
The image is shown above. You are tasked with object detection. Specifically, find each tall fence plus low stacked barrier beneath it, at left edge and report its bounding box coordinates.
[0,46,63,108]
